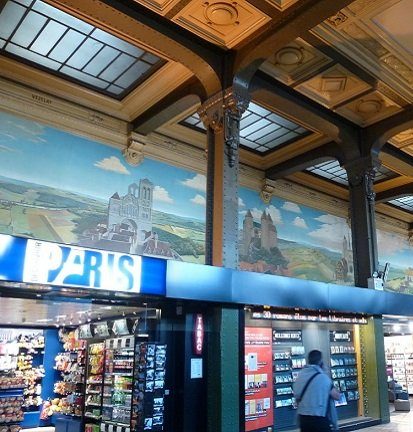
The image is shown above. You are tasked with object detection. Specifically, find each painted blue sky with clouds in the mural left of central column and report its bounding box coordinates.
[0,113,205,220]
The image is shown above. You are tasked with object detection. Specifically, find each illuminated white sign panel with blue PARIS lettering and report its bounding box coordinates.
[23,240,142,293]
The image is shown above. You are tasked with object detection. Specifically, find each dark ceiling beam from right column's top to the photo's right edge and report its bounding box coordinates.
[363,105,413,153]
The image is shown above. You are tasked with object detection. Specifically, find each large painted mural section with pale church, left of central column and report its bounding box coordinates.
[0,109,206,263]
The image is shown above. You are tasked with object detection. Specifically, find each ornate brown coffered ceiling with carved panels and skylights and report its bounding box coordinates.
[0,0,413,223]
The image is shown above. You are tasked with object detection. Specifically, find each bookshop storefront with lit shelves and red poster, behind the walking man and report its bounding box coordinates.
[245,307,372,431]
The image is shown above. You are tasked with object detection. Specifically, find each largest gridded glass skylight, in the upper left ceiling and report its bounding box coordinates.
[0,0,165,99]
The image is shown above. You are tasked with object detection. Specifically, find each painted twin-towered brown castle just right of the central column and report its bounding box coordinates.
[241,210,277,255]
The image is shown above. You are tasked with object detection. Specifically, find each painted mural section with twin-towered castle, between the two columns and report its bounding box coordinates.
[239,188,354,285]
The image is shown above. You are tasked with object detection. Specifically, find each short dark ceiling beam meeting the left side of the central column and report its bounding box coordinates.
[132,77,205,135]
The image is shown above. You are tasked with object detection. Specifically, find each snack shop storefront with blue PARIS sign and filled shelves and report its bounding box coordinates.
[0,235,208,432]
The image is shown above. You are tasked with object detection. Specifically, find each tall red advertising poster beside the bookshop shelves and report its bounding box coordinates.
[245,327,274,432]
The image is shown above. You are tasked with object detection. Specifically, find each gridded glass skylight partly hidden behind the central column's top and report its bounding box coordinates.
[181,102,310,154]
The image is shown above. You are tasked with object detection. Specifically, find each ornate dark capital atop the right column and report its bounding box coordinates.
[344,157,381,201]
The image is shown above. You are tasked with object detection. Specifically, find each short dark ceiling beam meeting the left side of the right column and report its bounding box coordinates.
[265,141,340,180]
